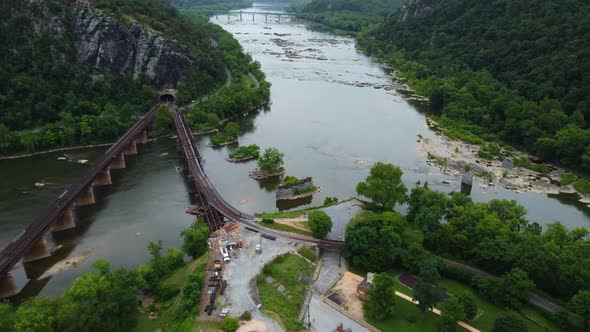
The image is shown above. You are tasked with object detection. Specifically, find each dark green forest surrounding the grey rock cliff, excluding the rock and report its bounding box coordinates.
[0,0,263,154]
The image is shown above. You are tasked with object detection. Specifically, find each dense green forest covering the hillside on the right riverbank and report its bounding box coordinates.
[304,0,590,175]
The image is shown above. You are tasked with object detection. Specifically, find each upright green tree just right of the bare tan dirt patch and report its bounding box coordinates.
[365,273,395,319]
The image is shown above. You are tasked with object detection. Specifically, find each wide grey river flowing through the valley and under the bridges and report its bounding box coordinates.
[0,4,590,295]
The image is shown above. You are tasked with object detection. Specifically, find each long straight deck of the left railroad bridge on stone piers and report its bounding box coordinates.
[0,105,159,274]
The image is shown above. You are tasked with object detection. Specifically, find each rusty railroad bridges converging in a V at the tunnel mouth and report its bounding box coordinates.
[0,96,342,298]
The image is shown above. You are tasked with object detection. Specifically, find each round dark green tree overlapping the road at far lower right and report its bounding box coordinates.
[497,268,535,309]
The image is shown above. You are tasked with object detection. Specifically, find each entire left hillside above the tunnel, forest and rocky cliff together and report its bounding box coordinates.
[0,0,229,154]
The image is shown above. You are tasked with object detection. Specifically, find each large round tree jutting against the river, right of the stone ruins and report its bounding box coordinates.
[356,162,406,210]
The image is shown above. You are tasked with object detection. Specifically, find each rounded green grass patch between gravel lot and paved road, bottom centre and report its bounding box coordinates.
[258,255,313,331]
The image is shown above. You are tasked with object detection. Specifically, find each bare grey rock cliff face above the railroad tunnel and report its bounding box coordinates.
[32,1,200,89]
